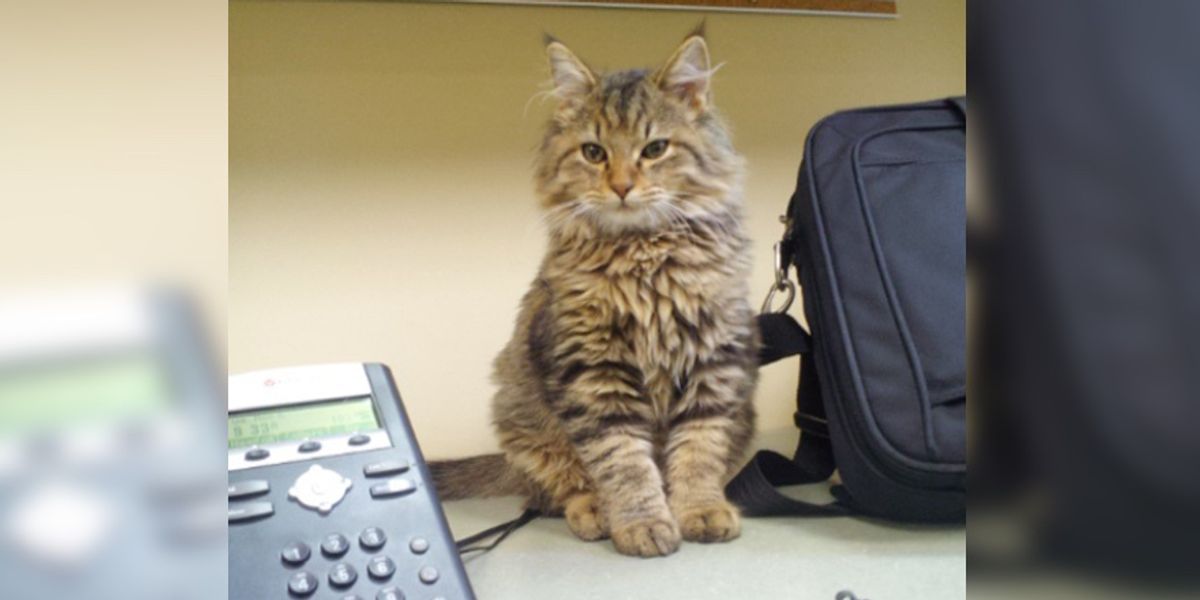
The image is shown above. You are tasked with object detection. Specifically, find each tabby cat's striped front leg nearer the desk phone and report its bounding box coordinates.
[559,360,680,557]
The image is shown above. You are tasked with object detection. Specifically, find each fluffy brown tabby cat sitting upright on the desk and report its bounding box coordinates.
[433,31,758,557]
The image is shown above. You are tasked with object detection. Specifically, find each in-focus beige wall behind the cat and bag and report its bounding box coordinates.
[229,0,966,457]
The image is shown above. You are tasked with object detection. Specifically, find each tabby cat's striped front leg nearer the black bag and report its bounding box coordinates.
[665,348,754,542]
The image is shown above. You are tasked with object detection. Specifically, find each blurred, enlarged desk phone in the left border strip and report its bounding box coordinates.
[0,287,227,600]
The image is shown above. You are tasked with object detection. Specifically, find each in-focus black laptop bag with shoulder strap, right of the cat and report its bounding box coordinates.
[727,98,966,522]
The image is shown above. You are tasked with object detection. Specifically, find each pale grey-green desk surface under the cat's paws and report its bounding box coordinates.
[445,441,966,600]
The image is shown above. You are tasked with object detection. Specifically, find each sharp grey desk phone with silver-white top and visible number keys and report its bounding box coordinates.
[228,364,475,600]
